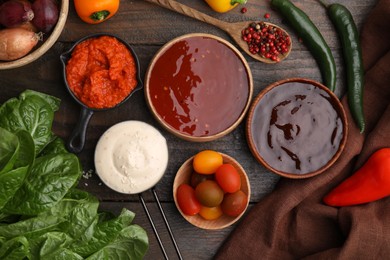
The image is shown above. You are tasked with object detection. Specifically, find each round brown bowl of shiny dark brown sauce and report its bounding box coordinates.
[246,78,348,179]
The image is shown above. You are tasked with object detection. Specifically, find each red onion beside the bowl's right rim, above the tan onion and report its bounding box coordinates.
[32,0,59,33]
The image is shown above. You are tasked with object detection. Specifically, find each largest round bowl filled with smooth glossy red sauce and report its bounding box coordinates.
[144,33,253,142]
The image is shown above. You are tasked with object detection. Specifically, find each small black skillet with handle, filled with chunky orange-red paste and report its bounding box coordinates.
[60,34,143,153]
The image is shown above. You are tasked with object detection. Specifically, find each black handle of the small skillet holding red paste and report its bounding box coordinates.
[67,107,93,153]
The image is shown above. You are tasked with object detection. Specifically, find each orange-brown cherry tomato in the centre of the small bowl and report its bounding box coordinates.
[195,180,224,207]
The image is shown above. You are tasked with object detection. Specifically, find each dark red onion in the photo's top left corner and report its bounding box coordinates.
[0,0,34,28]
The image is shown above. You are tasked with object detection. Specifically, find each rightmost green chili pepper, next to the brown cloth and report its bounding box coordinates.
[327,4,365,133]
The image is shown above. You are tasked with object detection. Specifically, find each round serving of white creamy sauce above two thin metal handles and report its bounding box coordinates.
[95,121,168,194]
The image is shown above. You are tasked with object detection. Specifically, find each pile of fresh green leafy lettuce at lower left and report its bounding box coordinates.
[0,90,149,260]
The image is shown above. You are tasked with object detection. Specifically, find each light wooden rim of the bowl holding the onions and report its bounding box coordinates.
[0,0,69,70]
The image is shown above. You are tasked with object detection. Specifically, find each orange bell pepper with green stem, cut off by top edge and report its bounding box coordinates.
[74,0,120,24]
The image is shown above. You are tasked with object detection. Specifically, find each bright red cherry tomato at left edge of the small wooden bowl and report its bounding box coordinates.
[176,183,201,216]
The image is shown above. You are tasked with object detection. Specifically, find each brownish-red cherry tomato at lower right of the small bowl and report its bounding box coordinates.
[221,190,248,217]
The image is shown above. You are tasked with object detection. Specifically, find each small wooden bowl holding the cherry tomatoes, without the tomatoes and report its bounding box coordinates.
[173,153,251,230]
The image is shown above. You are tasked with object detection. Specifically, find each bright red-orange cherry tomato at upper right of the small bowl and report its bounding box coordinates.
[215,163,241,193]
